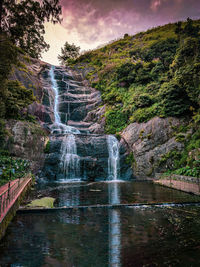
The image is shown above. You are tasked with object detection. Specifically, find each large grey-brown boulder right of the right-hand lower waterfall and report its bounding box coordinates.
[122,117,184,178]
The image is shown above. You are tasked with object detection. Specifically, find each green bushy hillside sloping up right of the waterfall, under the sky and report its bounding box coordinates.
[71,19,200,136]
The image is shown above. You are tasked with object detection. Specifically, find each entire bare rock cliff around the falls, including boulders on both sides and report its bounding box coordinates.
[7,59,187,180]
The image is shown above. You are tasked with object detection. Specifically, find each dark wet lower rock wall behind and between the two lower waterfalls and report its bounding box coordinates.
[43,135,132,181]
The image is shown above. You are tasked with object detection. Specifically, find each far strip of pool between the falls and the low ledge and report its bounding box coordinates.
[38,181,200,207]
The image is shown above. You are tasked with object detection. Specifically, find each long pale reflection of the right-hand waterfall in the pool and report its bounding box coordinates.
[108,182,121,267]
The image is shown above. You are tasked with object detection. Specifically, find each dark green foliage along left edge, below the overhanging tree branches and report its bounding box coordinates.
[0,34,36,145]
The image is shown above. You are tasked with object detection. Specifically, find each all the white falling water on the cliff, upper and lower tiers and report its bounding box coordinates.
[49,66,120,182]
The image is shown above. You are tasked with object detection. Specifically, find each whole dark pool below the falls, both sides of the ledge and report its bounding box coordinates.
[0,182,200,267]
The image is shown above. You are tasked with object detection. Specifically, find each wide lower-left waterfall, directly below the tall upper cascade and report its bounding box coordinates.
[60,134,80,179]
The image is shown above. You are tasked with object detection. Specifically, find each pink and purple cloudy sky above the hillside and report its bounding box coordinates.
[43,0,200,65]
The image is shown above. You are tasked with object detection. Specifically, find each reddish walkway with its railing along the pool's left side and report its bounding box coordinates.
[0,178,32,223]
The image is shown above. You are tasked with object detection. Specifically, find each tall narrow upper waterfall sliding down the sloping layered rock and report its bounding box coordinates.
[49,66,80,134]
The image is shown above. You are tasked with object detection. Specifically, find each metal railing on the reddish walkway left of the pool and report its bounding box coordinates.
[0,178,27,222]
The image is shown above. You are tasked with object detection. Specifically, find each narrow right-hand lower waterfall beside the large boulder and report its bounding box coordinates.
[107,135,120,180]
